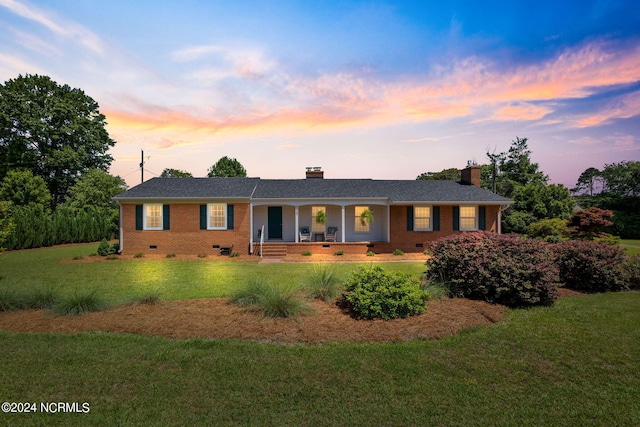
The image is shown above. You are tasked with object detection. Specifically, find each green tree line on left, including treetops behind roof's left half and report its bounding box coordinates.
[0,75,247,250]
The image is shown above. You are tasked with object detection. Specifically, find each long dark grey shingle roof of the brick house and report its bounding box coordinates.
[115,178,511,204]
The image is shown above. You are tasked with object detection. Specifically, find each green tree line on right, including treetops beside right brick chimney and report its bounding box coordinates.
[416,137,640,239]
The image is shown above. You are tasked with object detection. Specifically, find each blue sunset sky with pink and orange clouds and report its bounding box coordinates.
[0,0,640,188]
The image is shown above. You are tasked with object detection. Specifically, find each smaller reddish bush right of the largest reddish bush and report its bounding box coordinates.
[555,240,625,292]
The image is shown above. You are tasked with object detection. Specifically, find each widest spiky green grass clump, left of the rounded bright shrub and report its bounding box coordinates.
[231,279,311,317]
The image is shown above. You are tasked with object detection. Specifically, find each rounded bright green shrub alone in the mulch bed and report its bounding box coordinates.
[342,266,428,320]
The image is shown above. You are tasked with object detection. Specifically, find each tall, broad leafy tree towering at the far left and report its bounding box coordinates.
[0,75,115,205]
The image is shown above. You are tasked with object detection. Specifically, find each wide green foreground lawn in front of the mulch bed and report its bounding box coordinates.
[0,293,640,426]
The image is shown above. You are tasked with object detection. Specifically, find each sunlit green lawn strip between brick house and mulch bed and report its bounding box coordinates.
[0,243,425,303]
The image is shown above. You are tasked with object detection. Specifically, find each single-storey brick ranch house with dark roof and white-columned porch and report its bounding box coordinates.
[114,166,513,255]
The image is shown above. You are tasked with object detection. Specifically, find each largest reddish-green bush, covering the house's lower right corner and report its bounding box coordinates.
[427,232,559,307]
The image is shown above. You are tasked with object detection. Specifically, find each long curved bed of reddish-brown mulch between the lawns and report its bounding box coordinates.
[0,298,506,343]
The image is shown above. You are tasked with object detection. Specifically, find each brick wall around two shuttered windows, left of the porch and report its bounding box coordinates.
[122,203,249,255]
